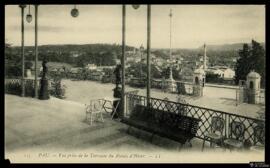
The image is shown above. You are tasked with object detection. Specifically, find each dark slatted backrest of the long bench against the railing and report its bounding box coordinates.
[130,105,201,136]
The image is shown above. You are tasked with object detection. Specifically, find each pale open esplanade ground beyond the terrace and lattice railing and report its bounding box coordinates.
[60,80,265,118]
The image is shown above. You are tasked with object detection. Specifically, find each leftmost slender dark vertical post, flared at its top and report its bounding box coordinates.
[19,5,26,97]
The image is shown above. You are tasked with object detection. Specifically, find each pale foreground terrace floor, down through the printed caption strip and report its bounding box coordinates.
[5,94,264,163]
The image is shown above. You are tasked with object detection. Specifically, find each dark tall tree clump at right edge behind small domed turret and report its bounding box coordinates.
[235,40,265,86]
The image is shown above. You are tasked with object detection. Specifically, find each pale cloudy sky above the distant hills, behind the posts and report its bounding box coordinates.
[5,4,265,48]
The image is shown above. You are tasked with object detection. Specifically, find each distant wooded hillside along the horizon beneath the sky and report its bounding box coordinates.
[8,43,265,67]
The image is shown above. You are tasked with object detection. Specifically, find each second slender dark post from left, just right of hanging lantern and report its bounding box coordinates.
[35,5,38,98]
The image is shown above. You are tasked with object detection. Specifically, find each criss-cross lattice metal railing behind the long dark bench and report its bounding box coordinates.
[125,94,265,145]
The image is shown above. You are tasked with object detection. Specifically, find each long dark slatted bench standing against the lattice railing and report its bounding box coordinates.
[121,105,201,147]
